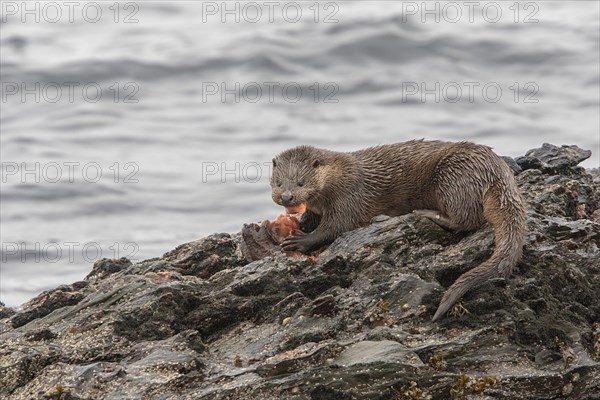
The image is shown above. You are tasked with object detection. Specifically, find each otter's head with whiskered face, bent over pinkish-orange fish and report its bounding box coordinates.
[271,146,323,207]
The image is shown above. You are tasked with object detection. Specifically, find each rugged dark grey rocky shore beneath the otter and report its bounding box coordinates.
[0,144,600,400]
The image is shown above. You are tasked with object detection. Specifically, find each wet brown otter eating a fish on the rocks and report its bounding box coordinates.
[270,140,526,321]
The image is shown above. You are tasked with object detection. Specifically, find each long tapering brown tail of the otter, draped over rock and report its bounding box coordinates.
[433,184,526,321]
